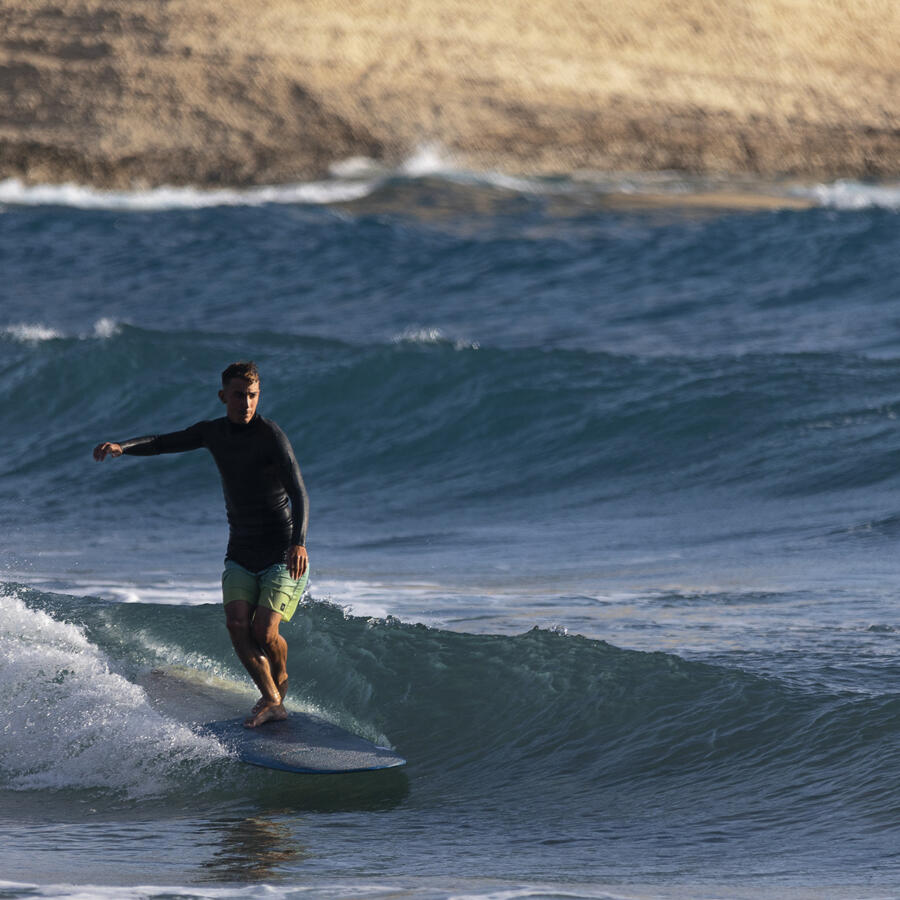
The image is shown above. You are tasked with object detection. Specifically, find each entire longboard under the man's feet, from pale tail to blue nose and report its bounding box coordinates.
[139,666,406,775]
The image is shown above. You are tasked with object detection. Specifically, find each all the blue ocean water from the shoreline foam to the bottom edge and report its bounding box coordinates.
[0,157,900,900]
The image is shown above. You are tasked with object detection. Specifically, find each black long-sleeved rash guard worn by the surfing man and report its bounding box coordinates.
[119,416,309,572]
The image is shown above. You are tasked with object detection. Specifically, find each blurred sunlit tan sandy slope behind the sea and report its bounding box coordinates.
[0,0,900,186]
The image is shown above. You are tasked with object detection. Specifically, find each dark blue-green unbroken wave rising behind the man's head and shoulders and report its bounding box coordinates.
[7,320,900,506]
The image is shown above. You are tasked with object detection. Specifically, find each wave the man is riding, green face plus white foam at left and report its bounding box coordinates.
[7,586,900,843]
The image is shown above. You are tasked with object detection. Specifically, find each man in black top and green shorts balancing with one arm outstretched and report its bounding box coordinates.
[94,362,309,728]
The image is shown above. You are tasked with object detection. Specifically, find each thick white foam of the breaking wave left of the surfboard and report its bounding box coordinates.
[0,592,224,797]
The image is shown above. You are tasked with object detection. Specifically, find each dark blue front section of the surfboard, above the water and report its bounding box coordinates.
[202,712,406,775]
